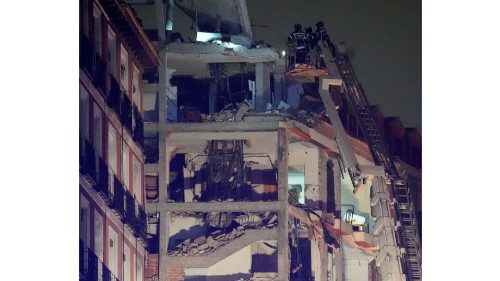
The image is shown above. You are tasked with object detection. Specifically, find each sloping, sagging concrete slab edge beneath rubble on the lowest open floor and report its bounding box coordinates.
[167,229,278,268]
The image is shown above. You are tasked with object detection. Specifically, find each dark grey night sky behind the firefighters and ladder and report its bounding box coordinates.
[247,0,422,131]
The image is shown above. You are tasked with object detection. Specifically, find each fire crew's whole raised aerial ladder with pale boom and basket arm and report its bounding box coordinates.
[287,32,422,281]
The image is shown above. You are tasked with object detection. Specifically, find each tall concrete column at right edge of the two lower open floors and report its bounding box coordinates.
[276,129,290,281]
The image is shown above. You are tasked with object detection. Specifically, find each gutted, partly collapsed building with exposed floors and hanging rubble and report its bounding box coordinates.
[79,0,421,281]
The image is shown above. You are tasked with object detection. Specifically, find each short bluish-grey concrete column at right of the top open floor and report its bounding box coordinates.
[255,62,271,112]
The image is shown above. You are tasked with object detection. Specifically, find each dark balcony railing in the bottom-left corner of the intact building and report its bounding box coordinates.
[80,239,119,281]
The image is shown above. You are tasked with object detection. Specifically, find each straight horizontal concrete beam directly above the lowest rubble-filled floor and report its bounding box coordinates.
[147,201,280,213]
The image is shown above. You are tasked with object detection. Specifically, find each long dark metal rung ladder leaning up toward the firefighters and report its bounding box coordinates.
[328,43,422,281]
